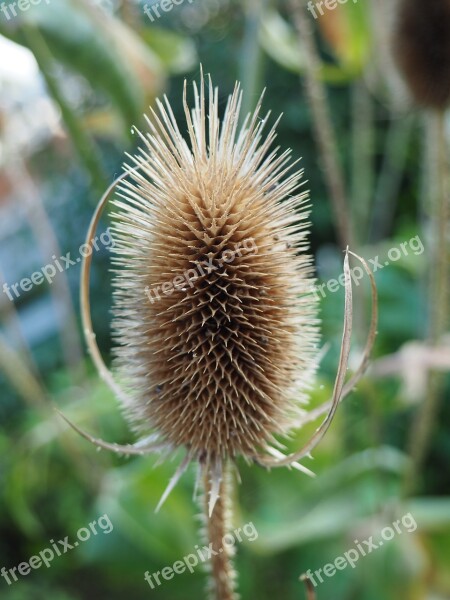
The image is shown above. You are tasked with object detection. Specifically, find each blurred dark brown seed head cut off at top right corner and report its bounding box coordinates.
[393,0,450,109]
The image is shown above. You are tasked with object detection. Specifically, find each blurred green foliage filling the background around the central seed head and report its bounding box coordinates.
[0,0,450,600]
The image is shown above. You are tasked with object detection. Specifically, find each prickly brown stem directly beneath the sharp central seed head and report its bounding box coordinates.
[204,469,238,600]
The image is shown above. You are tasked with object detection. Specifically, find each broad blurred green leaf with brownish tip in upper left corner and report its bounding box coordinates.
[1,0,164,131]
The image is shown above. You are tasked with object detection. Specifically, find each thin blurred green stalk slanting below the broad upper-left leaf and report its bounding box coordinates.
[22,21,108,193]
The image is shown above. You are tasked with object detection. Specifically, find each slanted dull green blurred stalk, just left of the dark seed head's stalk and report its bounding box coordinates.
[369,116,415,242]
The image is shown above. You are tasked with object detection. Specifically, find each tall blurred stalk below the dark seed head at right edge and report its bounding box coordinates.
[404,111,450,494]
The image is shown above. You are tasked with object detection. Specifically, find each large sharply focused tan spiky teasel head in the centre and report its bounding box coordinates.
[110,75,318,462]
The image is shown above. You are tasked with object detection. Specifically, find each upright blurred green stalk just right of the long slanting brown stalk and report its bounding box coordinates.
[351,79,375,245]
